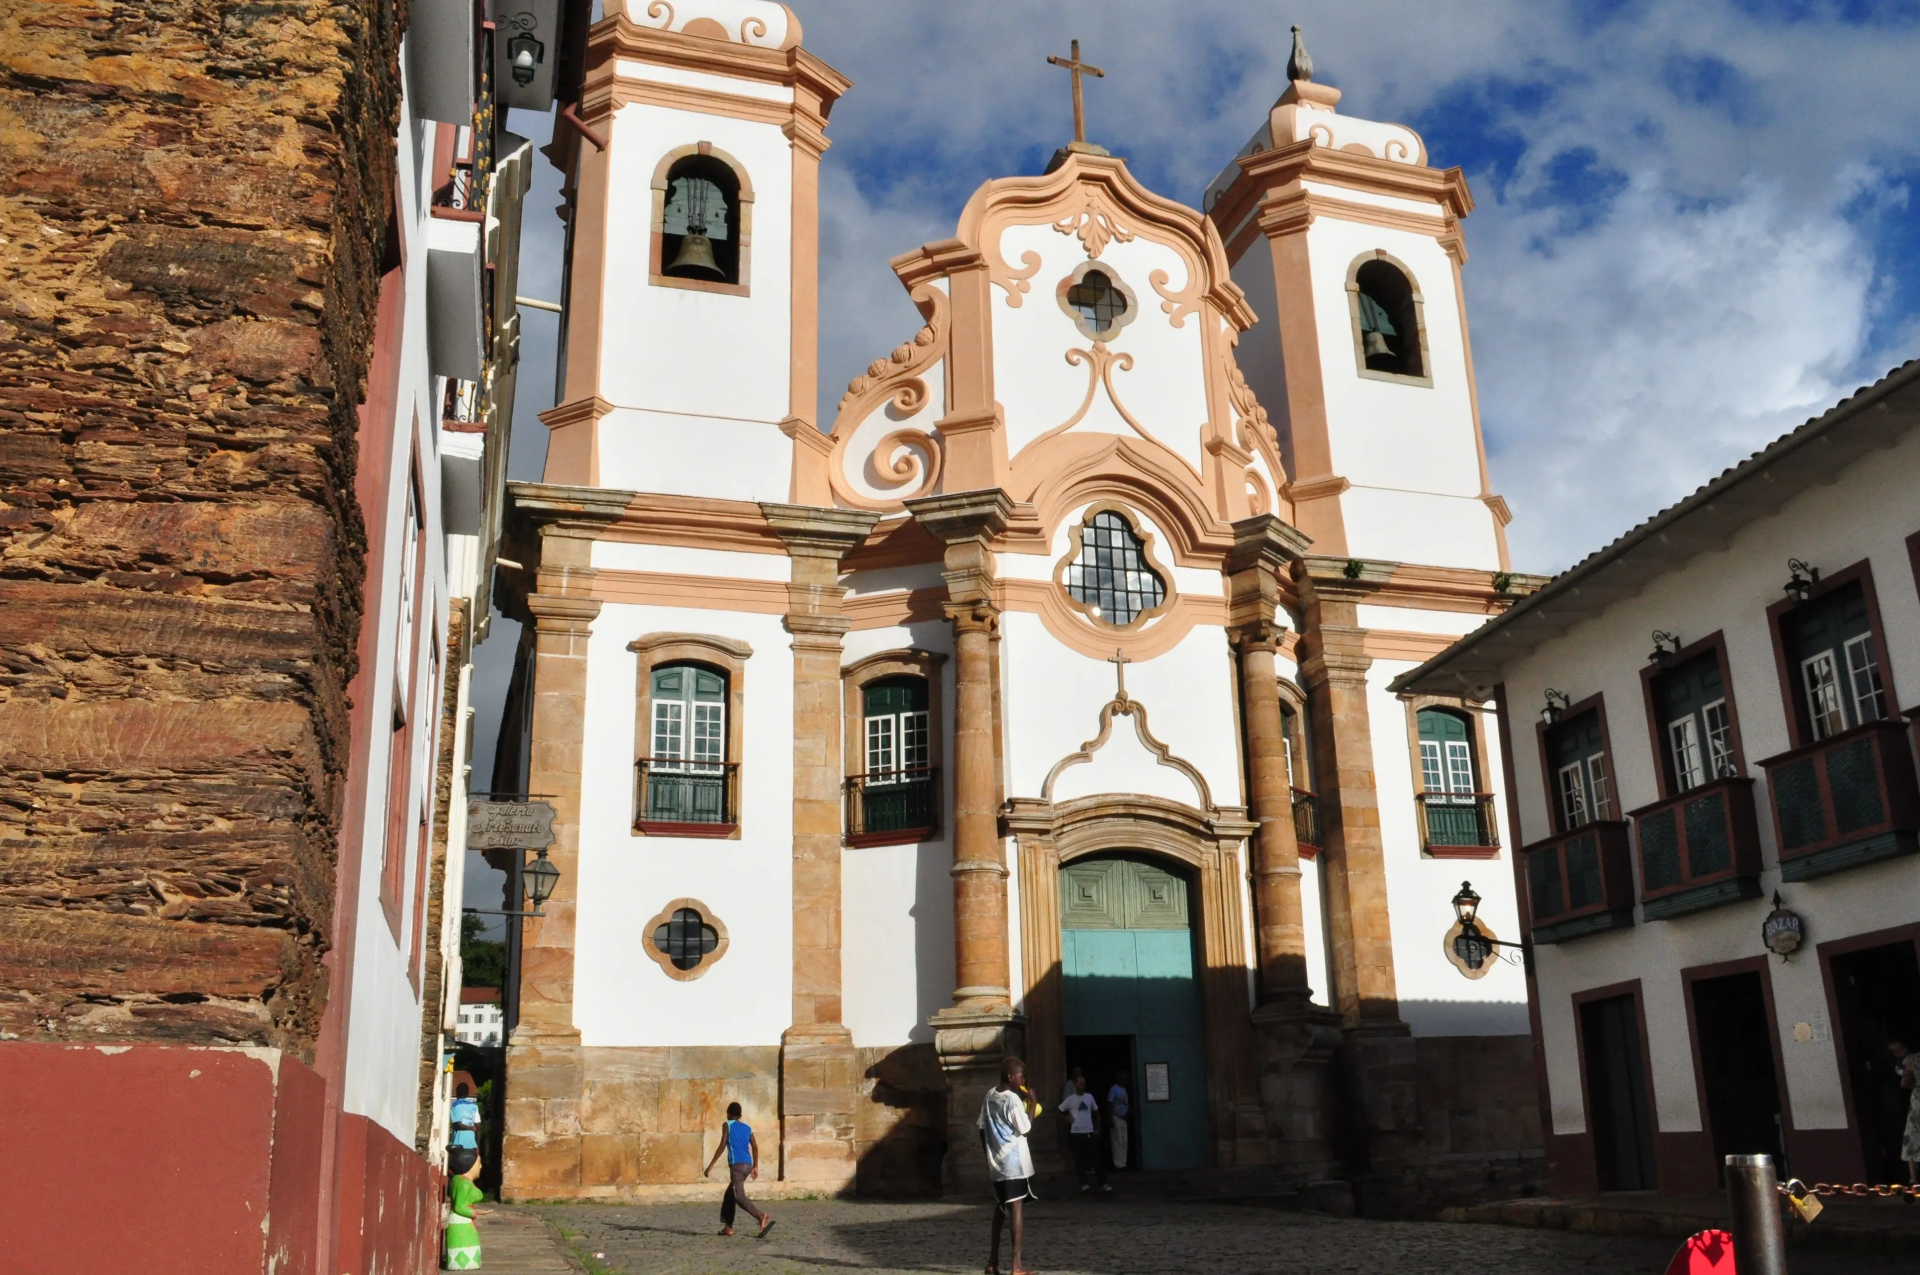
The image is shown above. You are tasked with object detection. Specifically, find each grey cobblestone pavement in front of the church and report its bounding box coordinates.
[540,1198,1914,1275]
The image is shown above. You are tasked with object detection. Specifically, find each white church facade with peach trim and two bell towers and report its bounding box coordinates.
[493,0,1540,1198]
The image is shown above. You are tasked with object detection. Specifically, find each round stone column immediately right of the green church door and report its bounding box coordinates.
[1227,515,1340,1179]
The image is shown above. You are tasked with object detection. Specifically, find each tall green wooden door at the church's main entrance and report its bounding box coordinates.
[1060,858,1208,1169]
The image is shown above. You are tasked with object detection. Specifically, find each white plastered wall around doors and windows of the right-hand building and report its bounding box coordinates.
[1507,434,1920,1133]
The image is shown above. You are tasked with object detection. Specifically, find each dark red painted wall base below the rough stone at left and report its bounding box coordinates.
[0,1041,444,1275]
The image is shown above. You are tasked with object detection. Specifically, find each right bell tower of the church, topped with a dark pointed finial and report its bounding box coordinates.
[1204,27,1509,570]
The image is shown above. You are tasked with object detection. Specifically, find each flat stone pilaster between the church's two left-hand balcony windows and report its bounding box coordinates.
[760,503,879,1191]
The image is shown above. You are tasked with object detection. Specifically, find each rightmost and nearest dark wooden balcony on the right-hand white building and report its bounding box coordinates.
[1761,720,1920,881]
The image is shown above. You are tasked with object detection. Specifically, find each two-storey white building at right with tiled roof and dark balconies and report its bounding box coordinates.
[1394,363,1920,1194]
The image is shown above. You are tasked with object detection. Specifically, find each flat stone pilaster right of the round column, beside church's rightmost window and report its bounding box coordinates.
[1298,557,1421,1202]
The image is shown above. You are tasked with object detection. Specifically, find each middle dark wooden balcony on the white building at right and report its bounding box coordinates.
[1628,778,1761,922]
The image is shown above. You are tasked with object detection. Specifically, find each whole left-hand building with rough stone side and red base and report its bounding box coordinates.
[0,0,560,1275]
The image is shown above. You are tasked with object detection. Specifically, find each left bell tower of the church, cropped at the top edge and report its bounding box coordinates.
[541,0,849,501]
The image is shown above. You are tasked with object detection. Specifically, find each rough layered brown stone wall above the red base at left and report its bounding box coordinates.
[0,0,405,1056]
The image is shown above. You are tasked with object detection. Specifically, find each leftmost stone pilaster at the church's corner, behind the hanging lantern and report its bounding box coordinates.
[501,488,630,1200]
